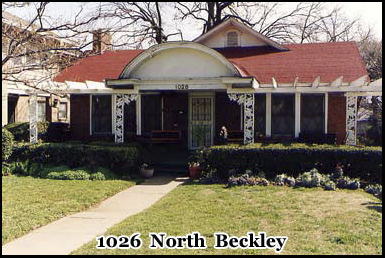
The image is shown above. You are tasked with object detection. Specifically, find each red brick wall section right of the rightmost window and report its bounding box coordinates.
[328,93,346,144]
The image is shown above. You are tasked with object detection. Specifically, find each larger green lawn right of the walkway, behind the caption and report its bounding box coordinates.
[72,184,382,255]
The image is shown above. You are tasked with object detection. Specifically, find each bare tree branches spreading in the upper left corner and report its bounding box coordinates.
[2,2,127,92]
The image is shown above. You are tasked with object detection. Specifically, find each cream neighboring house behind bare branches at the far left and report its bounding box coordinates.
[2,12,74,126]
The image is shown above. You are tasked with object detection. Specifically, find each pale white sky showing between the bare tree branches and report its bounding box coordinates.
[3,2,382,40]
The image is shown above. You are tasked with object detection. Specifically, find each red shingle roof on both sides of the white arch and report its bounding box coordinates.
[55,42,367,83]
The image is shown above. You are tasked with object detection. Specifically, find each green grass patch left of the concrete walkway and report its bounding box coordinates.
[2,176,135,244]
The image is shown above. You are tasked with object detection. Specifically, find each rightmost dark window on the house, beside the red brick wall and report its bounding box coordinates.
[301,94,325,133]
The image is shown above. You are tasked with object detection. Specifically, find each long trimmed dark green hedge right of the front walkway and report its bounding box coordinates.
[201,143,382,183]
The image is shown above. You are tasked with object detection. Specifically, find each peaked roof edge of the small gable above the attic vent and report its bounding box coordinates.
[193,18,288,51]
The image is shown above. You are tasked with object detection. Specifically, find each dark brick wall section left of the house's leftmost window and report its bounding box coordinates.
[70,94,90,140]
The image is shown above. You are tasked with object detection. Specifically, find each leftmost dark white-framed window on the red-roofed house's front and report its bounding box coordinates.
[92,95,112,133]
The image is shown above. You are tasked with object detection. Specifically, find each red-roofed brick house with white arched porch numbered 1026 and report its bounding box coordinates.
[27,19,382,149]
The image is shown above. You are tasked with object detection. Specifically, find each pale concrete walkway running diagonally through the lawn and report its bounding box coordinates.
[2,175,188,255]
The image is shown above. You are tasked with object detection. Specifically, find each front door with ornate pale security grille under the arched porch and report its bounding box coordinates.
[189,95,214,149]
